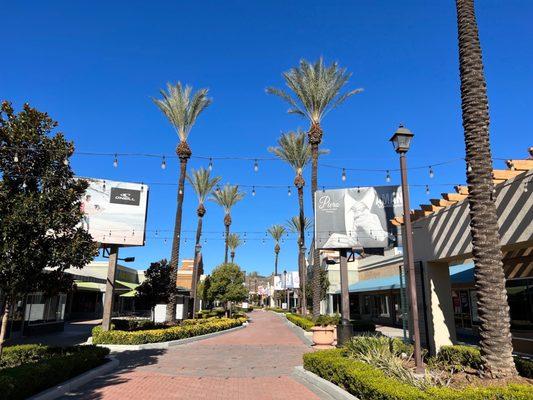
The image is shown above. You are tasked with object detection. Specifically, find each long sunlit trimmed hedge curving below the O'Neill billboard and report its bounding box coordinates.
[93,318,246,345]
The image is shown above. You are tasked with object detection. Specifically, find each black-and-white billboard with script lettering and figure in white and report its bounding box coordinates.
[315,186,403,249]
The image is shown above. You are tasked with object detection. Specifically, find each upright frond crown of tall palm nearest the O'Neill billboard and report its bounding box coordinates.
[152,82,213,141]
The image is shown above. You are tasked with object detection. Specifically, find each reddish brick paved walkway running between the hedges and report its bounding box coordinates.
[62,311,319,400]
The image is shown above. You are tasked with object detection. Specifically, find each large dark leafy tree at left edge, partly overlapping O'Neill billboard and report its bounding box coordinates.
[0,101,97,356]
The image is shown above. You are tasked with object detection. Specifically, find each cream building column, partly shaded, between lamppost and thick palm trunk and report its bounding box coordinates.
[417,262,456,354]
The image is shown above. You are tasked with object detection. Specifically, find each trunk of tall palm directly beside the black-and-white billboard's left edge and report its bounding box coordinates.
[308,123,322,318]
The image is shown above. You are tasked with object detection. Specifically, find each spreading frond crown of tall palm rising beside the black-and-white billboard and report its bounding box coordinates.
[267,57,362,123]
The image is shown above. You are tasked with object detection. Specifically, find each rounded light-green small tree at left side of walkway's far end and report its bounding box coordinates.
[208,264,248,311]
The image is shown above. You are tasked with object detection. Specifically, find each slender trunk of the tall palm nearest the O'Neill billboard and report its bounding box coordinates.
[166,141,191,322]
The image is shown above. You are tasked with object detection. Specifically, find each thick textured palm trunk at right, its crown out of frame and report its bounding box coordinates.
[456,0,516,377]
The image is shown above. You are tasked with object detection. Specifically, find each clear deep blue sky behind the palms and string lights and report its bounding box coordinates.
[0,0,533,274]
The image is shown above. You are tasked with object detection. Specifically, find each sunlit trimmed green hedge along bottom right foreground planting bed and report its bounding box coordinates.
[304,349,533,400]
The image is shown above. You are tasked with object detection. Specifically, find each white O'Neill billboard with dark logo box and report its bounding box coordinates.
[81,178,148,246]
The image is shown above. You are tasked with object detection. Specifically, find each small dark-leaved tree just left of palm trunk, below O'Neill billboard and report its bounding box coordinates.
[136,259,172,309]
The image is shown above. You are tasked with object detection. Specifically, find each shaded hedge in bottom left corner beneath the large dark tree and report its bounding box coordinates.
[0,346,109,400]
